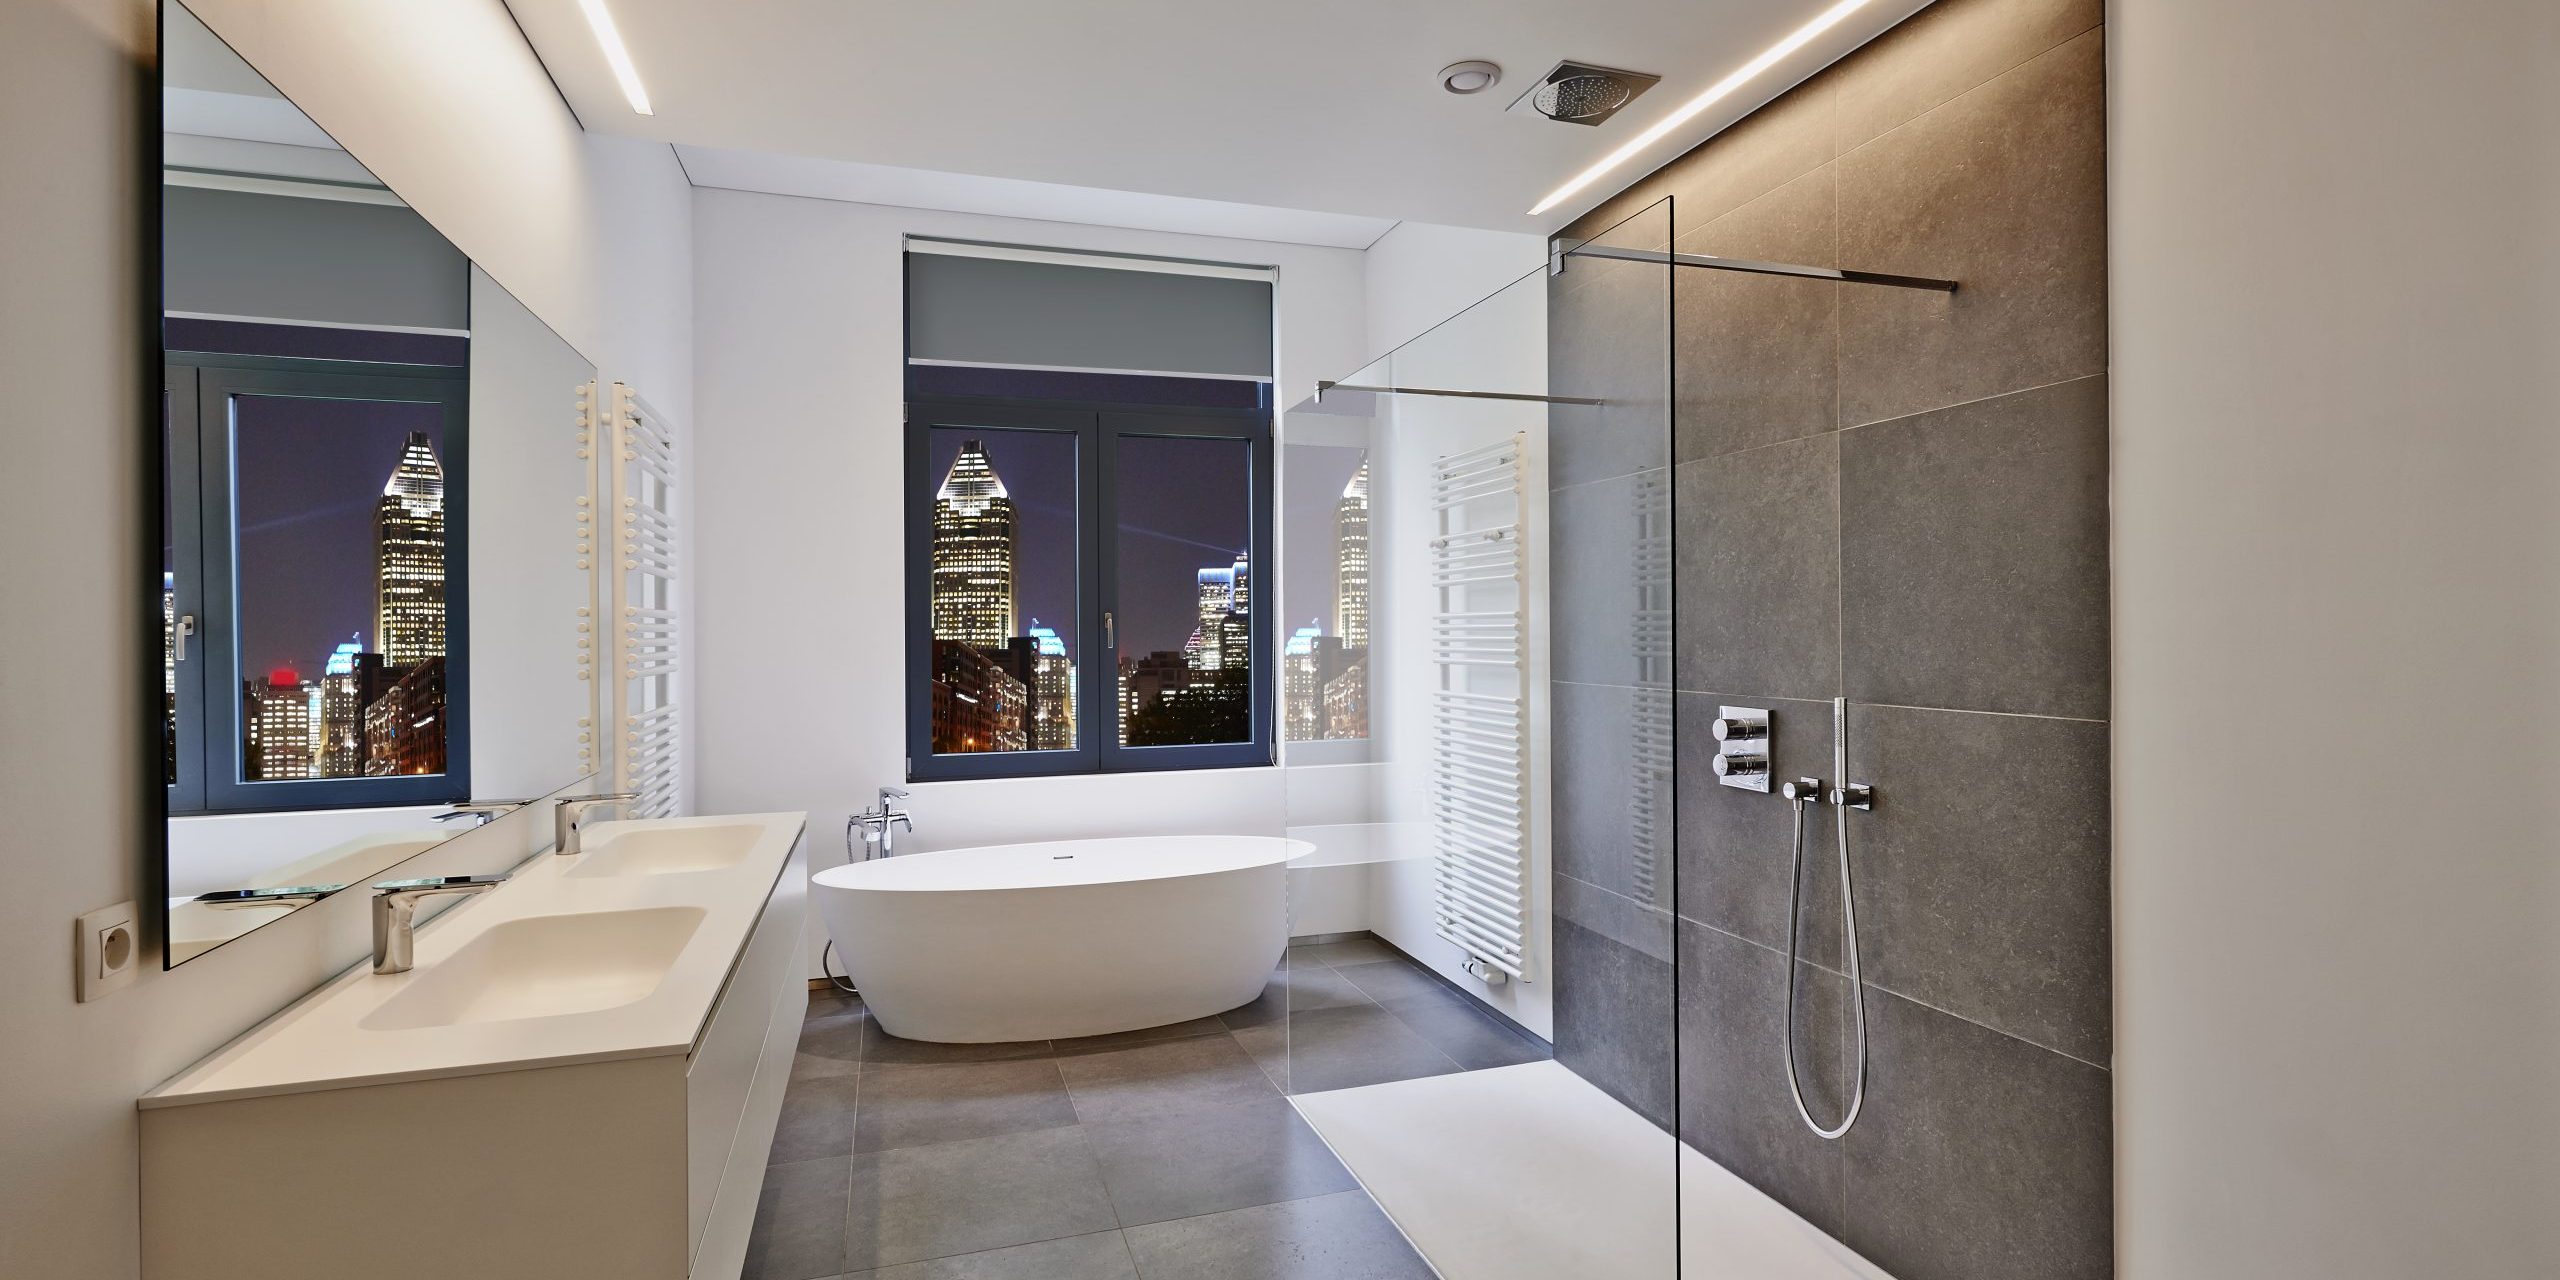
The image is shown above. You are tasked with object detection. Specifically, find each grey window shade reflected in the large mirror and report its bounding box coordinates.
[161,187,471,330]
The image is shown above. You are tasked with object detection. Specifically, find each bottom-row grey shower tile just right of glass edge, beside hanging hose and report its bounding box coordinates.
[1679,922,1851,1236]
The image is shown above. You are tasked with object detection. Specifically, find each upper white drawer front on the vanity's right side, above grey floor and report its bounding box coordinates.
[686,850,809,1257]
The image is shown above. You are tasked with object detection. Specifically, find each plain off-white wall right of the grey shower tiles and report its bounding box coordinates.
[2107,0,2560,1280]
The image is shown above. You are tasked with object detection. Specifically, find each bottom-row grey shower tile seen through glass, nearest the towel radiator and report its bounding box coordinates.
[1554,919,1677,1129]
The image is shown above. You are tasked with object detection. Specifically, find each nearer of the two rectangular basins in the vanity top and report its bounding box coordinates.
[358,906,704,1032]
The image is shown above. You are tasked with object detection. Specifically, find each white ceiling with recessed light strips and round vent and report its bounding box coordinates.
[509,0,1928,243]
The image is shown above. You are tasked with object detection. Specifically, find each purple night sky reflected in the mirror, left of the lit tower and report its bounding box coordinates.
[233,397,453,678]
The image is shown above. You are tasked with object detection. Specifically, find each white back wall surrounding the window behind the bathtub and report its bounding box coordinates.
[694,189,1367,973]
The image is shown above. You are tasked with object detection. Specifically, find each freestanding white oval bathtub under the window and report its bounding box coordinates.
[809,835,1313,1044]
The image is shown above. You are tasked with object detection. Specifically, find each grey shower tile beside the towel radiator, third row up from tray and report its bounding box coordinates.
[1546,471,1669,684]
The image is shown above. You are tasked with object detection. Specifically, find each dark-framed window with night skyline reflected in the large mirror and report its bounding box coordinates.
[161,333,471,814]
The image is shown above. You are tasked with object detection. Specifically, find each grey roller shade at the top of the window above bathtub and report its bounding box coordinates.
[906,253,1272,379]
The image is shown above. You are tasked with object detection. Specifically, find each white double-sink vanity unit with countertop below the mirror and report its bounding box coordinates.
[141,814,806,1280]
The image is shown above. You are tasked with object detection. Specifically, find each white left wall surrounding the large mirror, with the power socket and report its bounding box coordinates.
[0,0,691,1280]
